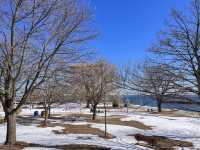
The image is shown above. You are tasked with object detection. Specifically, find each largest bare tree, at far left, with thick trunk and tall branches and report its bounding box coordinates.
[0,0,96,145]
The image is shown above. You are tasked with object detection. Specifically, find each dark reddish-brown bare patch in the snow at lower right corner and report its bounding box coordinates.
[130,134,193,150]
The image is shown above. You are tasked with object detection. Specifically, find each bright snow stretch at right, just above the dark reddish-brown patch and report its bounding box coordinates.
[121,113,200,148]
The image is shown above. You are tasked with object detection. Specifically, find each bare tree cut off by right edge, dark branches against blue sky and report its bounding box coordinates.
[150,0,200,99]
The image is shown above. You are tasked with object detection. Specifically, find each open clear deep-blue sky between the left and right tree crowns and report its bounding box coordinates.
[90,0,190,65]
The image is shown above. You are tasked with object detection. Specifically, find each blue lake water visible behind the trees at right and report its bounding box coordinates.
[123,95,200,112]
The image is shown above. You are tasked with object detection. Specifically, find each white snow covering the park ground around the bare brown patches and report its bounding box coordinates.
[0,104,200,150]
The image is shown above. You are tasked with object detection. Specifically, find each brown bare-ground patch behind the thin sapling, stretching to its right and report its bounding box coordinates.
[88,116,151,130]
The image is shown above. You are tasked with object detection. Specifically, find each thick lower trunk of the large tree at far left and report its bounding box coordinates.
[5,113,16,145]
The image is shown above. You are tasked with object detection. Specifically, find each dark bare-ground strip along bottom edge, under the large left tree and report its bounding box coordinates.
[0,142,110,150]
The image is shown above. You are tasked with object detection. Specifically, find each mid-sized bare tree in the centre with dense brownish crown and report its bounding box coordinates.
[70,60,116,120]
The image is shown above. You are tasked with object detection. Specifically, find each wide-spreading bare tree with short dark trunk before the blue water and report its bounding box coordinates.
[120,62,184,112]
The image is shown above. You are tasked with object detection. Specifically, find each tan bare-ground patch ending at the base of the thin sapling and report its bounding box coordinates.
[54,124,114,139]
